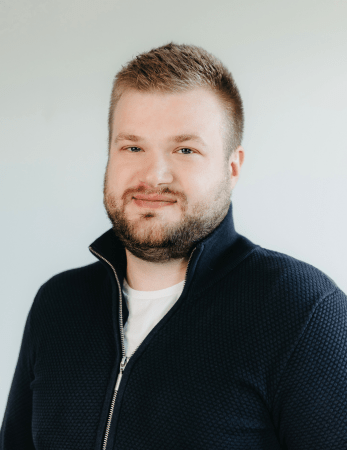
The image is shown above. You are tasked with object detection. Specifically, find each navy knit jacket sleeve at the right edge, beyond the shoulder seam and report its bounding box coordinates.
[274,289,347,450]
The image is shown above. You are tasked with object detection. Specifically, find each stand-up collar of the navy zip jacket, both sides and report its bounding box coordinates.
[89,203,258,294]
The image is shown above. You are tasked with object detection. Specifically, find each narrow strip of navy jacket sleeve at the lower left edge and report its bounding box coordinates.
[0,311,35,450]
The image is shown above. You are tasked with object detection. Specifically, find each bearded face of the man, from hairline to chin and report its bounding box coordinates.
[104,88,242,262]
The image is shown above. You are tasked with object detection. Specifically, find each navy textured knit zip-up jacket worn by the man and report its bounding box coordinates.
[0,204,347,450]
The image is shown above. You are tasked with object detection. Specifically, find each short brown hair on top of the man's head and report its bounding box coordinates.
[108,42,244,157]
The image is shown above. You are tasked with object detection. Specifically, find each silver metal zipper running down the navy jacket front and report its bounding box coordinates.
[89,247,196,450]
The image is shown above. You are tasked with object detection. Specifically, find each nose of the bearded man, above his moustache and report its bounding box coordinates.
[140,154,173,187]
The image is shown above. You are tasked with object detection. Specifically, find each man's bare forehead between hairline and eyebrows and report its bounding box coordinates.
[111,88,227,146]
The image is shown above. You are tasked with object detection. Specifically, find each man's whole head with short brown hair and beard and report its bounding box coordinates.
[104,44,243,262]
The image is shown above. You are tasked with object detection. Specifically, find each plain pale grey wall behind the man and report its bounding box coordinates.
[0,0,347,420]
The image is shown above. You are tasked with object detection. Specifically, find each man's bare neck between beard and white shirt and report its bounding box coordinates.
[125,249,188,291]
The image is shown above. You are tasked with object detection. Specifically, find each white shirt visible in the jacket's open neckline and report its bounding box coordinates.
[122,278,184,357]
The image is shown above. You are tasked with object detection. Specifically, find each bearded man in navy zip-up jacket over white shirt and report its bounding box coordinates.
[0,44,347,450]
